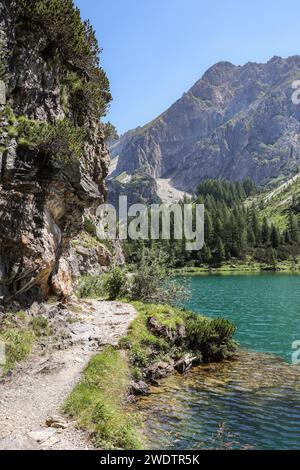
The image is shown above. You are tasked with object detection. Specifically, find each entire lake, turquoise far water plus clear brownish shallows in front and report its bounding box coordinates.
[141,274,300,450]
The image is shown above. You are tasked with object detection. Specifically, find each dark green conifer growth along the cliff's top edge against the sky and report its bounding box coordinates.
[16,0,112,118]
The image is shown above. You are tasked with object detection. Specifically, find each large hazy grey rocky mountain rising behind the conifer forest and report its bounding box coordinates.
[111,56,300,191]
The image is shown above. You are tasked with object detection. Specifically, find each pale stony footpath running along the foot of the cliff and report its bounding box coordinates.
[0,301,136,450]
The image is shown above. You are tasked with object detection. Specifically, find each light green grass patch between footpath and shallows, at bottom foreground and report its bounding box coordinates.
[64,346,143,450]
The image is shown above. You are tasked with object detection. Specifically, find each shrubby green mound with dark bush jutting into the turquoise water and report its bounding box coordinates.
[120,302,235,375]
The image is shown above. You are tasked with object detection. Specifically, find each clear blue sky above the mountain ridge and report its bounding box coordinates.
[75,0,300,133]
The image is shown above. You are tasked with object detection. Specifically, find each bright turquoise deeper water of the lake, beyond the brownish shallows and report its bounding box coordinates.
[185,274,300,362]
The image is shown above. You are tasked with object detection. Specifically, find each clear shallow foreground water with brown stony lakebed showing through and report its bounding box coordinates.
[136,347,300,450]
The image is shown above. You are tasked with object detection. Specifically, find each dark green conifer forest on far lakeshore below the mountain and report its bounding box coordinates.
[125,179,300,269]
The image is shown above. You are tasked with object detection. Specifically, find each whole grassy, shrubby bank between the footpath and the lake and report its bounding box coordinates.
[64,302,235,450]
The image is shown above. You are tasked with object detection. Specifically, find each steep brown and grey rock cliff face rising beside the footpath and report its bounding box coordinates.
[0,0,109,303]
